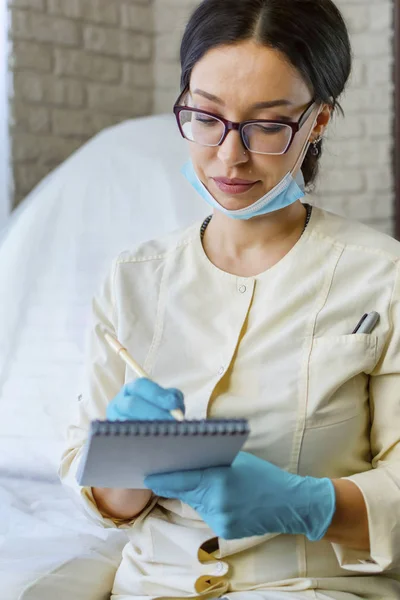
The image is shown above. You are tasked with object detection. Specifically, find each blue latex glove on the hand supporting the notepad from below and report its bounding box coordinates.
[145,452,336,541]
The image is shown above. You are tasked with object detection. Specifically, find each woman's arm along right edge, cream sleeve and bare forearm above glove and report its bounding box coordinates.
[327,264,400,573]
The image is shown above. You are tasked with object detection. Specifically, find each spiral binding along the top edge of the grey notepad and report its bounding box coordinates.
[91,419,249,436]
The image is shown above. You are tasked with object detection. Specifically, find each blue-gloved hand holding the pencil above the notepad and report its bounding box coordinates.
[107,379,185,421]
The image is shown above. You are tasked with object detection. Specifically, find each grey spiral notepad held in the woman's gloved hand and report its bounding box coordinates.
[77,419,249,489]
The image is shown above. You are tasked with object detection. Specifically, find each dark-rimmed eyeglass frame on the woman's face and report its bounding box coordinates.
[173,89,316,156]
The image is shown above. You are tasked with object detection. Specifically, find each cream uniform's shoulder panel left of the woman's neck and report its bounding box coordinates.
[114,221,202,268]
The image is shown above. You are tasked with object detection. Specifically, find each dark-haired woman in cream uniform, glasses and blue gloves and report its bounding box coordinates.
[61,0,400,600]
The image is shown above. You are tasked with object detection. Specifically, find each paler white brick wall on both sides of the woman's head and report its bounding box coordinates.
[154,0,394,234]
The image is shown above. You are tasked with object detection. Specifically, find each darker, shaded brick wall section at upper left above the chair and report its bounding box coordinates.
[8,0,153,203]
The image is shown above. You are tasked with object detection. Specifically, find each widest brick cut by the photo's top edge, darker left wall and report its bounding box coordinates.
[48,0,119,25]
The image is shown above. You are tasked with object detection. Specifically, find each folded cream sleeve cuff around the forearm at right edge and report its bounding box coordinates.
[332,466,400,574]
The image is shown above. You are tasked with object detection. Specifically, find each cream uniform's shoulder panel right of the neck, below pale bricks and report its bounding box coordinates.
[312,207,400,263]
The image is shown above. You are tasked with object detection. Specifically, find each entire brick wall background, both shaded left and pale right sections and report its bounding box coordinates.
[9,0,394,233]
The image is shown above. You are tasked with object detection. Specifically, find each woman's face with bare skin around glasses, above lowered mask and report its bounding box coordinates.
[188,41,324,210]
